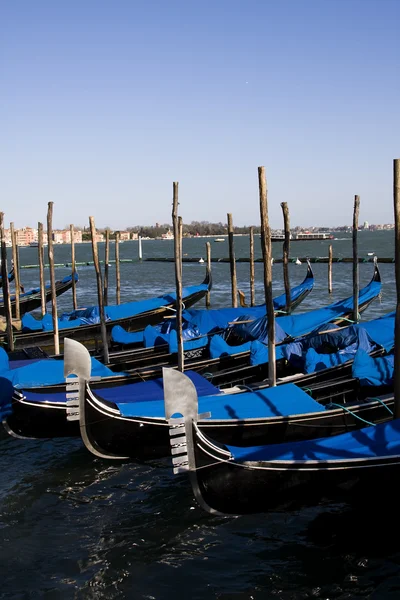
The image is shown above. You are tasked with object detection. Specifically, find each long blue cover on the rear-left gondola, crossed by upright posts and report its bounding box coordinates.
[22,283,208,332]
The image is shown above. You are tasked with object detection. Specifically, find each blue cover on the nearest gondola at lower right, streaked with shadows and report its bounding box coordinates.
[228,419,400,467]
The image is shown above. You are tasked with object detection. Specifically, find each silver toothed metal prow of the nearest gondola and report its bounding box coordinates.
[163,367,221,515]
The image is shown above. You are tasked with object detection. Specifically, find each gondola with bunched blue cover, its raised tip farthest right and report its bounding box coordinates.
[99,265,382,385]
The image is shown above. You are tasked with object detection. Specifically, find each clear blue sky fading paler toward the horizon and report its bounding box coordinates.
[0,0,400,228]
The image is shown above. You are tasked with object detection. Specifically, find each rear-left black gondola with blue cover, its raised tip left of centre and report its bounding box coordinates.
[0,270,212,354]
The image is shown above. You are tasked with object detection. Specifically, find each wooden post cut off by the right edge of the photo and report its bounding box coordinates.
[393,158,400,419]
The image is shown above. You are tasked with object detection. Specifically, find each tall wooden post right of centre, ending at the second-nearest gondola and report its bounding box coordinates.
[258,167,276,387]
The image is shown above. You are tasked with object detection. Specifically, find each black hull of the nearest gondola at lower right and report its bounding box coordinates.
[190,442,400,515]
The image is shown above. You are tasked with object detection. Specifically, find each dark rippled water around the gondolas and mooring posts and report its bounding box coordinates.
[0,232,400,600]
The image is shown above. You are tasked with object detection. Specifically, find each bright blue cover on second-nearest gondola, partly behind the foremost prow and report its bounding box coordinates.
[116,383,325,420]
